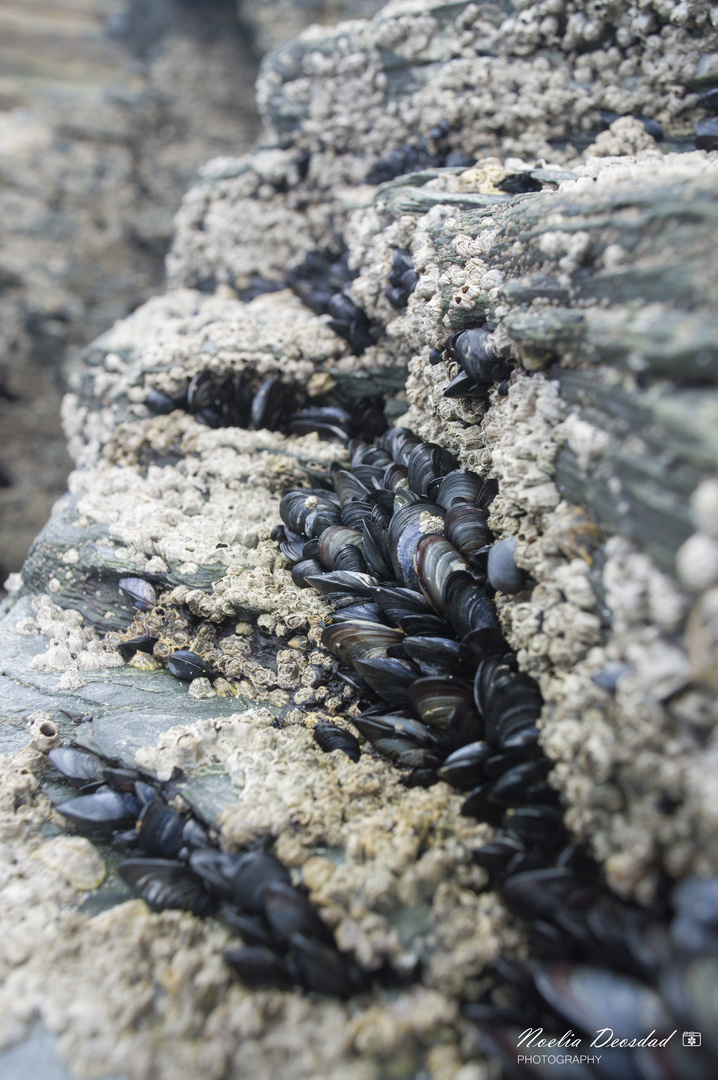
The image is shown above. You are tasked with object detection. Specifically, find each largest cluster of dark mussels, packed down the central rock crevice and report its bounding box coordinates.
[275,416,718,1080]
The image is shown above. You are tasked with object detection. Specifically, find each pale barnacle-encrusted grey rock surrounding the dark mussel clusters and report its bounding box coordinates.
[0,0,718,1080]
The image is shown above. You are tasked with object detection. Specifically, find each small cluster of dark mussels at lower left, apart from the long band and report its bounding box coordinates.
[48,746,368,998]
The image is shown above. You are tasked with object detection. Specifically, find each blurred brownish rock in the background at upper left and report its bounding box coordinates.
[0,0,381,595]
